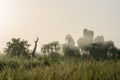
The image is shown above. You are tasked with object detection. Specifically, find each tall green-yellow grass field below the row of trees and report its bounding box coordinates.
[0,56,120,80]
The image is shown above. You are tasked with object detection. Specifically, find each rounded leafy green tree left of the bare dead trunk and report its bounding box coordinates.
[5,38,30,56]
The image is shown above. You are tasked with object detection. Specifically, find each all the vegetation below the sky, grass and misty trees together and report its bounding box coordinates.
[0,29,120,80]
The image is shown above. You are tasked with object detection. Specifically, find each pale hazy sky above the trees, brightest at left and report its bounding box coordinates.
[0,0,120,51]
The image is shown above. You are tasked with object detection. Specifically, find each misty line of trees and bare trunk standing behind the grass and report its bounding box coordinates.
[5,29,120,60]
